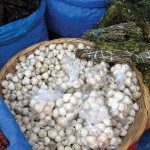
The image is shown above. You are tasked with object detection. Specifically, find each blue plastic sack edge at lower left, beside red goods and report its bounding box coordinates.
[0,99,32,150]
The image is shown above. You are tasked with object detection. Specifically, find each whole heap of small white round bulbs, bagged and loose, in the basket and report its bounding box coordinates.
[1,43,141,150]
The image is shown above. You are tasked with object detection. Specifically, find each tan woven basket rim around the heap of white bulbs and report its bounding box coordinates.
[0,38,150,150]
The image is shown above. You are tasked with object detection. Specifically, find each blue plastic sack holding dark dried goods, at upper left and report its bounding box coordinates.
[0,0,48,69]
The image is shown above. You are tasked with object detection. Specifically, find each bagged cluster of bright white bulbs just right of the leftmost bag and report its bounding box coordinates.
[53,92,82,127]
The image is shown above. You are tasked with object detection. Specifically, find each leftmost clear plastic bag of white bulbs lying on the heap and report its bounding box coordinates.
[30,89,62,124]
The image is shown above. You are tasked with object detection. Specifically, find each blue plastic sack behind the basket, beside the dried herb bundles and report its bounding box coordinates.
[46,0,110,38]
